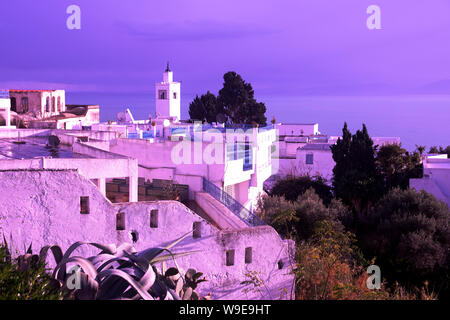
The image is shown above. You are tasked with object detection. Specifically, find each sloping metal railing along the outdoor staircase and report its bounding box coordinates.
[203,178,267,227]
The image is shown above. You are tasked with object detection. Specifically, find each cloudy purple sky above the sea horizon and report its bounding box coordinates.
[0,0,450,97]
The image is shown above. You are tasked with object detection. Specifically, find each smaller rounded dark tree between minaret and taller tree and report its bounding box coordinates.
[189,91,223,123]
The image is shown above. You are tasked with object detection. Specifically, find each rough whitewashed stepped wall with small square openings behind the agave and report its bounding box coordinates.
[0,170,294,299]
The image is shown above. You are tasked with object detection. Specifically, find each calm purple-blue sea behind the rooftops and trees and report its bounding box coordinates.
[66,92,450,150]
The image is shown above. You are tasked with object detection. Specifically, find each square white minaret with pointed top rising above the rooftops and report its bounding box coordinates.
[155,62,181,121]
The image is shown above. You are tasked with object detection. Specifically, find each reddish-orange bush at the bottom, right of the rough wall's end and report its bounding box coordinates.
[295,220,436,300]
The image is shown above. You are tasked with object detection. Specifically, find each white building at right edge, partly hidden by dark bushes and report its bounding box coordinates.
[409,154,450,207]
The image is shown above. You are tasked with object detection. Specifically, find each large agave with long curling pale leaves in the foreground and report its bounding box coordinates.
[10,232,206,300]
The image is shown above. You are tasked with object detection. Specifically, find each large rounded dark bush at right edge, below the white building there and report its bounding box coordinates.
[359,188,450,291]
